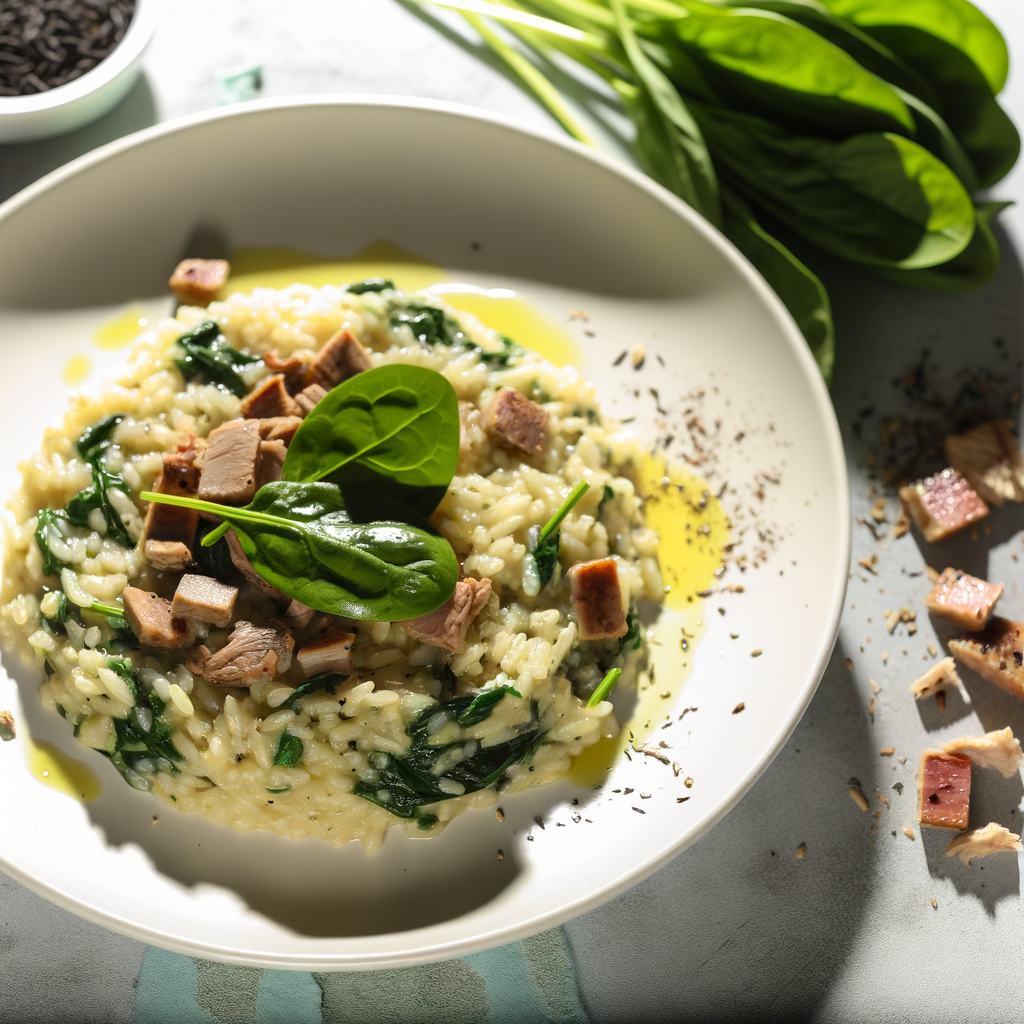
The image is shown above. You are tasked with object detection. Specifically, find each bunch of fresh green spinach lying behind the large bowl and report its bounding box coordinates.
[421,0,1020,380]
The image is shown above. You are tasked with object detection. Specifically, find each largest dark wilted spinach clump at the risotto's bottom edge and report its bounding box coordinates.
[355,687,543,828]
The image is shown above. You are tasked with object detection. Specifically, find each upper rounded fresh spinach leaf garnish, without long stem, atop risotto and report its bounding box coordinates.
[282,364,460,516]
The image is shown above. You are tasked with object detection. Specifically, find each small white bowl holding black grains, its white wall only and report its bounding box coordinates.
[0,0,162,142]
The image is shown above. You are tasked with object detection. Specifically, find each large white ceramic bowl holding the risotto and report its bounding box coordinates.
[0,97,850,970]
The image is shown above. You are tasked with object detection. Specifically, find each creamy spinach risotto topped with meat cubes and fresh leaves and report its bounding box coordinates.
[0,270,664,850]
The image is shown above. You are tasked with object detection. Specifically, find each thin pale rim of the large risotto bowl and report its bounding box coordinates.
[0,94,852,971]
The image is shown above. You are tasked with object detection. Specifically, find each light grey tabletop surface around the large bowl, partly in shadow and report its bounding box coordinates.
[0,0,1024,1024]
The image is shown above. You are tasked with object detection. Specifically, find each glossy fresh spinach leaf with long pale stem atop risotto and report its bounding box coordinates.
[141,480,459,622]
